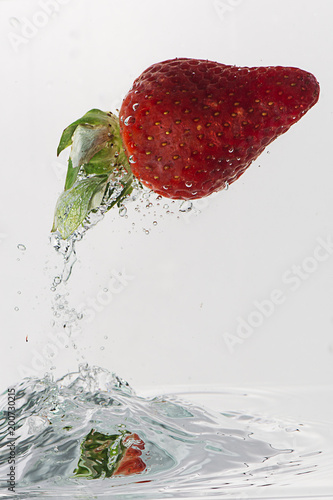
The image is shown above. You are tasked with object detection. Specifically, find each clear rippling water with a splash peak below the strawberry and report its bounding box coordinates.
[0,365,333,499]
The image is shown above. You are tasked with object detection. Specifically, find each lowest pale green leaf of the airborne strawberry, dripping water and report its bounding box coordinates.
[52,175,108,239]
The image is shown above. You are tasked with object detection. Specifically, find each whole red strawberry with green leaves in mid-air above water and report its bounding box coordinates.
[53,58,319,238]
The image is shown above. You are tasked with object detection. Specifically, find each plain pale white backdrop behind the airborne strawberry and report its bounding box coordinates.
[0,0,333,389]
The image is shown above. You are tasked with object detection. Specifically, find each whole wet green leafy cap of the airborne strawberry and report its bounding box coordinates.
[52,109,133,239]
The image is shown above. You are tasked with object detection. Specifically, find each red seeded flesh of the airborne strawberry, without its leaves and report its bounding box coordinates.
[119,58,319,200]
